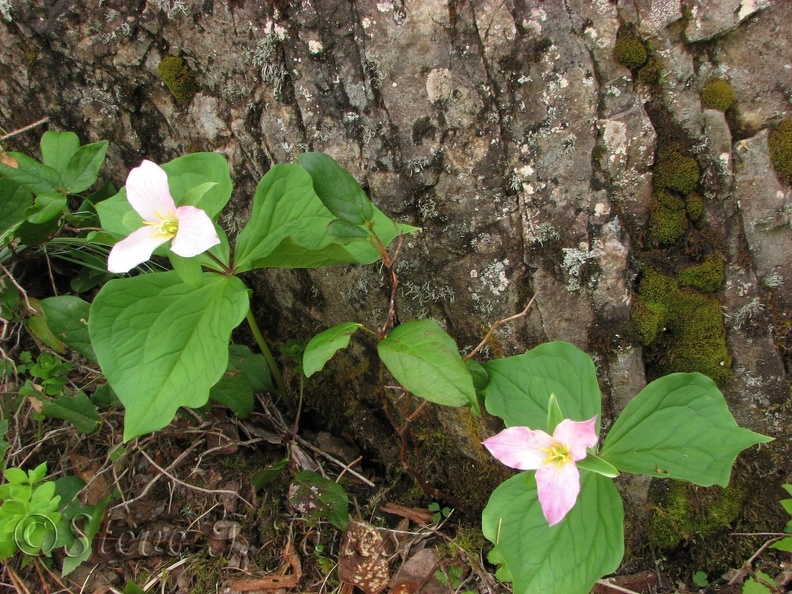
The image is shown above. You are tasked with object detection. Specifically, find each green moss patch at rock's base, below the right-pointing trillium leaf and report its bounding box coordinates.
[649,481,747,549]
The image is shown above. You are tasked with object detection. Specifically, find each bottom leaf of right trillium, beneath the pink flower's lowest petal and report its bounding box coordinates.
[481,472,624,594]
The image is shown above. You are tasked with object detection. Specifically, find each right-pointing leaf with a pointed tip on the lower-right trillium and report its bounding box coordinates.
[600,373,772,487]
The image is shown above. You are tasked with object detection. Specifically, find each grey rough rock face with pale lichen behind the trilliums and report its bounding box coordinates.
[0,0,792,572]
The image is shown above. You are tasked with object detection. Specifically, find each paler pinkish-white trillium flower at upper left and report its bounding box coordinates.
[107,161,220,272]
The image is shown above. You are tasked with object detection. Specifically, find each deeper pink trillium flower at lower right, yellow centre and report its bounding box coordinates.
[483,417,597,526]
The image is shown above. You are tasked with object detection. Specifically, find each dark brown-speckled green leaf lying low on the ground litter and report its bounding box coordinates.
[289,470,349,530]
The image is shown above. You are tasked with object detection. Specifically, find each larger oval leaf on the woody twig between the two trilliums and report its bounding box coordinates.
[377,320,479,413]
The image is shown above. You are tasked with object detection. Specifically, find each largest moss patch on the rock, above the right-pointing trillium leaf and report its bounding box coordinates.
[632,265,731,383]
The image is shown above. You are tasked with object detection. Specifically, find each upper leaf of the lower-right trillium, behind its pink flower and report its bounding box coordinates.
[483,341,601,430]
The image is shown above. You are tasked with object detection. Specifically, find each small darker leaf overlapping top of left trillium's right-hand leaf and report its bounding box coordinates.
[297,153,374,225]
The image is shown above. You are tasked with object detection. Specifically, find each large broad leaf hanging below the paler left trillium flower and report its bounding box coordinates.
[88,272,249,440]
